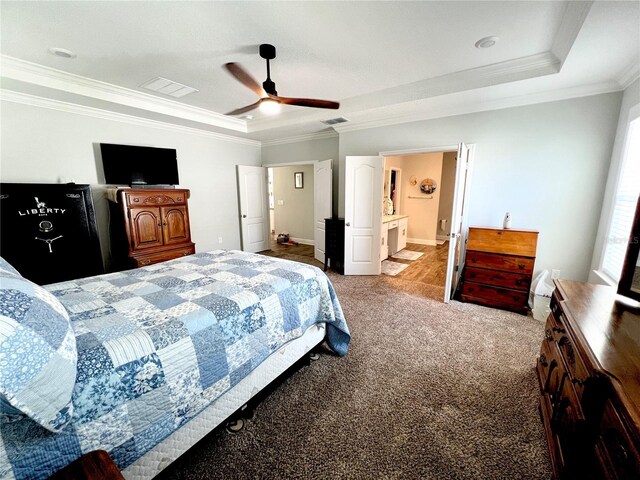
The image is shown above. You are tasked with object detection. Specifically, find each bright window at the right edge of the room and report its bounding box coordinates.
[601,118,640,282]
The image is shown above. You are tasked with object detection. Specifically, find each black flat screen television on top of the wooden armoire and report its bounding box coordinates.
[100,143,180,186]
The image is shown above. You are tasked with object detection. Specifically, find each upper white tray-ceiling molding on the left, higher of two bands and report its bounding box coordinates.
[0,55,247,133]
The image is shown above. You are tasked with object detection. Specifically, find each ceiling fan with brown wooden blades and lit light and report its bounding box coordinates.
[224,43,340,115]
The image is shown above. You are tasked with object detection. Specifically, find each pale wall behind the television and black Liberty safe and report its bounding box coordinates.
[0,101,261,265]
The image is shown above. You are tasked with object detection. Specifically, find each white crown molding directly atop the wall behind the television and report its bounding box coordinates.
[0,89,262,147]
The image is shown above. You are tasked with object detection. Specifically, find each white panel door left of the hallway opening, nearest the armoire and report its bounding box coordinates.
[237,165,270,252]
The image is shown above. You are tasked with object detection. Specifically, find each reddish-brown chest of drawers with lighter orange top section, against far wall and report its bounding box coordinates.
[460,227,538,313]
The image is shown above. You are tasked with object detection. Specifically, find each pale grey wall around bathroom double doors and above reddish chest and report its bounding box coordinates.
[339,93,622,280]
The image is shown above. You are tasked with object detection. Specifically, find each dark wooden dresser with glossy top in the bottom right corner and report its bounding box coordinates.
[536,280,640,480]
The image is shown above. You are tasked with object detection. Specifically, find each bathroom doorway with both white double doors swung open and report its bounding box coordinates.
[345,143,474,303]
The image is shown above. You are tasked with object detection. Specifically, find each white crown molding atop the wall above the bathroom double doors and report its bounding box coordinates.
[333,82,620,134]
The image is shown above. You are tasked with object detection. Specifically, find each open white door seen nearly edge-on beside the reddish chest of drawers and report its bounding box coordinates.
[444,143,471,303]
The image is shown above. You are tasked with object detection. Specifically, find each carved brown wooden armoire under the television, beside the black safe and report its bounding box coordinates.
[111,188,195,267]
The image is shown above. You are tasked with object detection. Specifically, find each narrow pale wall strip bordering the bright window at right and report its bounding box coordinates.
[589,79,640,283]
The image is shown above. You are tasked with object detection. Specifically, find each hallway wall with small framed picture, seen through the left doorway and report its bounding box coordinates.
[273,165,314,244]
